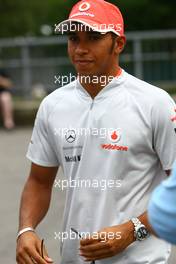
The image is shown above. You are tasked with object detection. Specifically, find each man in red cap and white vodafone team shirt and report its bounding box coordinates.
[17,0,176,264]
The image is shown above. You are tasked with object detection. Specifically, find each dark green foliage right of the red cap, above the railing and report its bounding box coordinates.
[111,0,176,31]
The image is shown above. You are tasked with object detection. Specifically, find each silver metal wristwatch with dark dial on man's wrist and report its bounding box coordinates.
[131,218,149,241]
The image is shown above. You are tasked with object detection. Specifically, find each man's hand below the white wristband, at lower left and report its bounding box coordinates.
[16,232,53,264]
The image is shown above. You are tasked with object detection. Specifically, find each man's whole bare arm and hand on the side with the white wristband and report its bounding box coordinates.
[16,164,58,264]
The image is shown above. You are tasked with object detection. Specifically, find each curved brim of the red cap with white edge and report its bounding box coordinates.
[55,19,120,36]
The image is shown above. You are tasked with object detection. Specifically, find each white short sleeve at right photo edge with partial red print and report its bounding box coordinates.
[152,92,176,170]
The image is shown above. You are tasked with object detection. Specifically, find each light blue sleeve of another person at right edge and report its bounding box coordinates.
[148,163,176,244]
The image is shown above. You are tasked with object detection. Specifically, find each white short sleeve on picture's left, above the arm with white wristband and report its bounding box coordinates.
[26,100,59,167]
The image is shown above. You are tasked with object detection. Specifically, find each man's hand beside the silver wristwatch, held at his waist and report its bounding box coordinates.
[80,221,135,261]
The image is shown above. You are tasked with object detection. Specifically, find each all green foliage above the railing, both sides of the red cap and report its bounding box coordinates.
[0,0,176,38]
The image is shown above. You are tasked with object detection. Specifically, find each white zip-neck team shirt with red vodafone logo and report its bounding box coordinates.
[27,71,176,264]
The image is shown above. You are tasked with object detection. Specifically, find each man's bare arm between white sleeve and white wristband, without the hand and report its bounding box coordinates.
[19,164,58,230]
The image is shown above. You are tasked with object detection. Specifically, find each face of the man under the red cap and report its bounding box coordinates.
[68,23,124,76]
